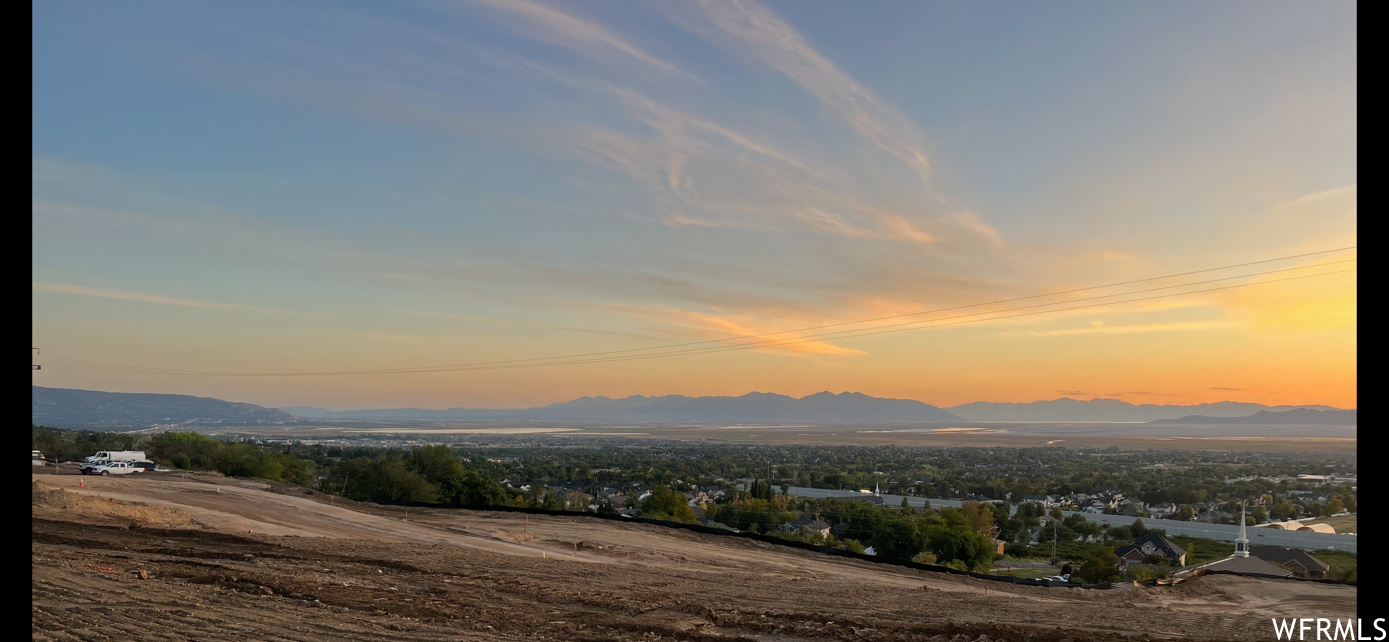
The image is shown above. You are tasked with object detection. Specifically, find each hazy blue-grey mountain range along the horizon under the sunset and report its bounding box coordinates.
[33,386,1356,427]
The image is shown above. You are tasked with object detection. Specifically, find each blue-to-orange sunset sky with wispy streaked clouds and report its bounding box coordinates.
[32,0,1357,410]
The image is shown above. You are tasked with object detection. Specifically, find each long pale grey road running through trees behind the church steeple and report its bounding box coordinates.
[790,486,1356,553]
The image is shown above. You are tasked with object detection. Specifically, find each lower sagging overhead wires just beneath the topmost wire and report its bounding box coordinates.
[50,261,1356,377]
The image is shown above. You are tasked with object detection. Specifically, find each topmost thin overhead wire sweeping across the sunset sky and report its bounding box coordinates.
[40,246,1357,375]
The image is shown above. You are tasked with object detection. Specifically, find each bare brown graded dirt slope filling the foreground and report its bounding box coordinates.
[32,474,1356,642]
